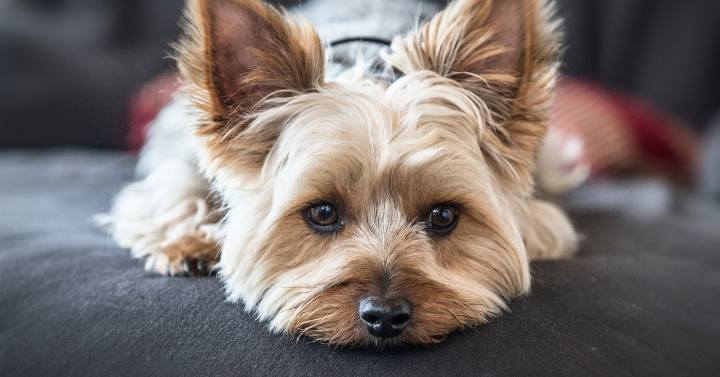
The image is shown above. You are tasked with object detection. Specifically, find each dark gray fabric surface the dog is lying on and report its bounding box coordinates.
[0,151,720,376]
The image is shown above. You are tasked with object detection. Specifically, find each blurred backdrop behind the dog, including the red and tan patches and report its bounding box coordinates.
[0,0,720,198]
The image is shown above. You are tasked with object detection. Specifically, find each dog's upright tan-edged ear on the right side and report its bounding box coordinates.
[389,0,561,186]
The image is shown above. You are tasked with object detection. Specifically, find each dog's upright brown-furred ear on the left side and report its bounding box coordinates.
[177,0,324,164]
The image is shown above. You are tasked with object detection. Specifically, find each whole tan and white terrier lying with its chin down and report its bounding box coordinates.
[106,0,578,347]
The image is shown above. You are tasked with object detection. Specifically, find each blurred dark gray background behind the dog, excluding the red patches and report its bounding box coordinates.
[0,0,720,148]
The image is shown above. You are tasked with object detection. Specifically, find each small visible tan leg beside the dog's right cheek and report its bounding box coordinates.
[523,200,578,260]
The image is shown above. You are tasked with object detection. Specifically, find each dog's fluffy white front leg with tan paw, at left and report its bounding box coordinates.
[101,160,220,275]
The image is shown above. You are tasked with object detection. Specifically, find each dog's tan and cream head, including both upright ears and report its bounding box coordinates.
[179,0,557,345]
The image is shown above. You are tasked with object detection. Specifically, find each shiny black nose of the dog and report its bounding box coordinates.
[358,296,412,338]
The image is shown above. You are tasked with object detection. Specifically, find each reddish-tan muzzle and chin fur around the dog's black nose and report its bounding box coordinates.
[288,282,504,349]
